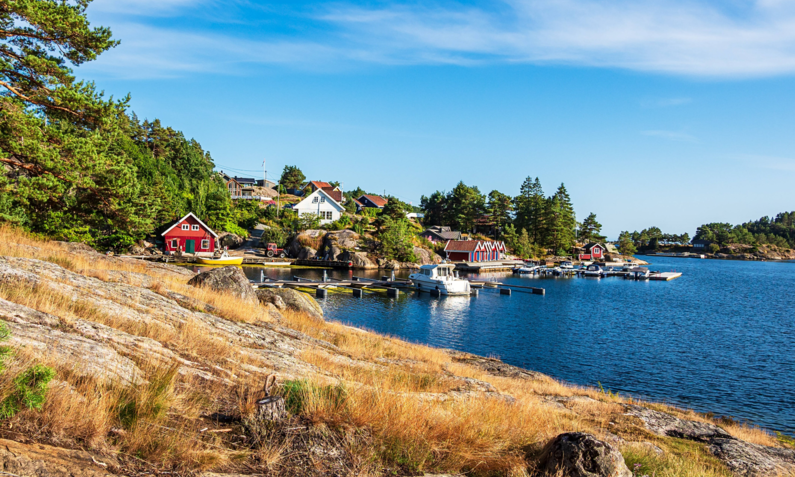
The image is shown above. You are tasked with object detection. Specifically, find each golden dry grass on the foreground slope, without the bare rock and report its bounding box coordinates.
[0,227,776,476]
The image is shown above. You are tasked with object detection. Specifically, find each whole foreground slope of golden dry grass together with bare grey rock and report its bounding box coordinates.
[0,227,779,477]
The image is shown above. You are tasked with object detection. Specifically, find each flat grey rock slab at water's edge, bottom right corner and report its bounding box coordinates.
[626,405,795,477]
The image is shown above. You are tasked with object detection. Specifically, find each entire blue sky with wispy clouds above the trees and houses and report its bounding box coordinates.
[78,0,795,238]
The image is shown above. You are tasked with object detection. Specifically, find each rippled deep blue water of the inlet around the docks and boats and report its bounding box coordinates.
[227,258,795,434]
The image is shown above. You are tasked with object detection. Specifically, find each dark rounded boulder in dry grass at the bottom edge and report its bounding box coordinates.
[539,432,632,477]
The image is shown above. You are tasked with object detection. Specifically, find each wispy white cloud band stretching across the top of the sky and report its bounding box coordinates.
[84,0,795,77]
